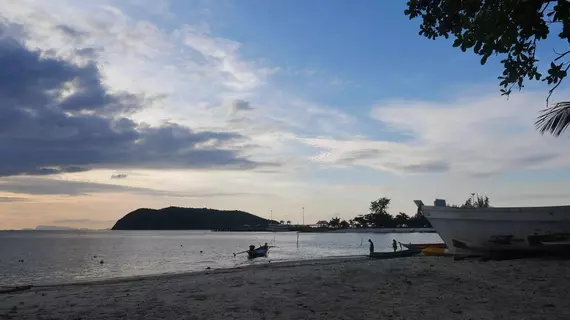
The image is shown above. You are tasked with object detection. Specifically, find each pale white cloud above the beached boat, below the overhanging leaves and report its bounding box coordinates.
[304,92,570,175]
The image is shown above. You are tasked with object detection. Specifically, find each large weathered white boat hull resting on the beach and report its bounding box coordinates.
[414,199,570,256]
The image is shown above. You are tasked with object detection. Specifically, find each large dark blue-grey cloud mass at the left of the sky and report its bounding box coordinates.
[0,25,259,176]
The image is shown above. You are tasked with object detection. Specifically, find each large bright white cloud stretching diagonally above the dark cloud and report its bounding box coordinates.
[2,0,364,178]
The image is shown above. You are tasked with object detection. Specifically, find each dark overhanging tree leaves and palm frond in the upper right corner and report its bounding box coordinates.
[404,0,570,136]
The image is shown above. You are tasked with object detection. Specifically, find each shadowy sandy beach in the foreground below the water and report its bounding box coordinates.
[0,257,570,320]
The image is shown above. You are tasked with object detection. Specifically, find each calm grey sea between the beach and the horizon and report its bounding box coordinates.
[0,231,441,286]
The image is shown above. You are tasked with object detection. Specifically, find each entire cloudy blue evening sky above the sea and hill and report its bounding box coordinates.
[0,0,570,229]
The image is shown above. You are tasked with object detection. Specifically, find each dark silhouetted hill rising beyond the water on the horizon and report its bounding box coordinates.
[112,207,271,230]
